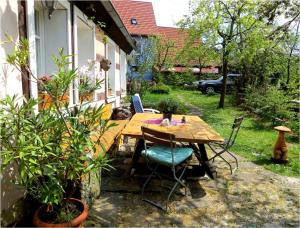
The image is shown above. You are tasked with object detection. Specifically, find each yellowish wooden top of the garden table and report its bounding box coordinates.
[122,113,224,143]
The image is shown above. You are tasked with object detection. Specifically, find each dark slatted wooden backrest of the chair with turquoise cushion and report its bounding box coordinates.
[142,126,176,148]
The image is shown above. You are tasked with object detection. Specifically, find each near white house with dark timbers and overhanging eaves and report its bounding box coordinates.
[0,0,134,226]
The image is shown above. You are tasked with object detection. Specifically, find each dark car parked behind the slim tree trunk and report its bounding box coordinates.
[198,74,241,94]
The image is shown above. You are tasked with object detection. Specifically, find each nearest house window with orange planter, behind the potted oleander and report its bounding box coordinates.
[33,1,70,109]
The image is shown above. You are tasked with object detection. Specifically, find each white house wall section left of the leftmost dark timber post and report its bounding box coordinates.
[0,1,24,225]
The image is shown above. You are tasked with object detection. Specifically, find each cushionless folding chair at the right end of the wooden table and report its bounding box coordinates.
[208,116,244,174]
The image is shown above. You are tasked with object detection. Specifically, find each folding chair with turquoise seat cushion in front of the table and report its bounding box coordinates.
[142,127,193,211]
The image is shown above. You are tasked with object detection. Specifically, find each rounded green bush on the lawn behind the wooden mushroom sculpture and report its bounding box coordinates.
[245,86,293,123]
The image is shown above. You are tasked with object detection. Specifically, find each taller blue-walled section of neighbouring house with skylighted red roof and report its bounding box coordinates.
[113,0,157,80]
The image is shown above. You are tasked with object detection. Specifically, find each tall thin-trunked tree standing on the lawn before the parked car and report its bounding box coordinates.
[182,0,256,108]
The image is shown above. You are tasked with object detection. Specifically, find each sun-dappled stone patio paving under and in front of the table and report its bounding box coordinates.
[85,147,300,227]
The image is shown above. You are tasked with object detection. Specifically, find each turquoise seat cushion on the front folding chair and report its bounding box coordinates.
[142,145,193,166]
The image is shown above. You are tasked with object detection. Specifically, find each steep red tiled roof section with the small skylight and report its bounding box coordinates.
[112,0,157,35]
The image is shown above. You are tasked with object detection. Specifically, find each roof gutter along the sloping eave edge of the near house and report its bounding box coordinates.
[101,1,135,49]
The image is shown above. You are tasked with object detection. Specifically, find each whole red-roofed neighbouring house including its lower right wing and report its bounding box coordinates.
[113,0,218,79]
